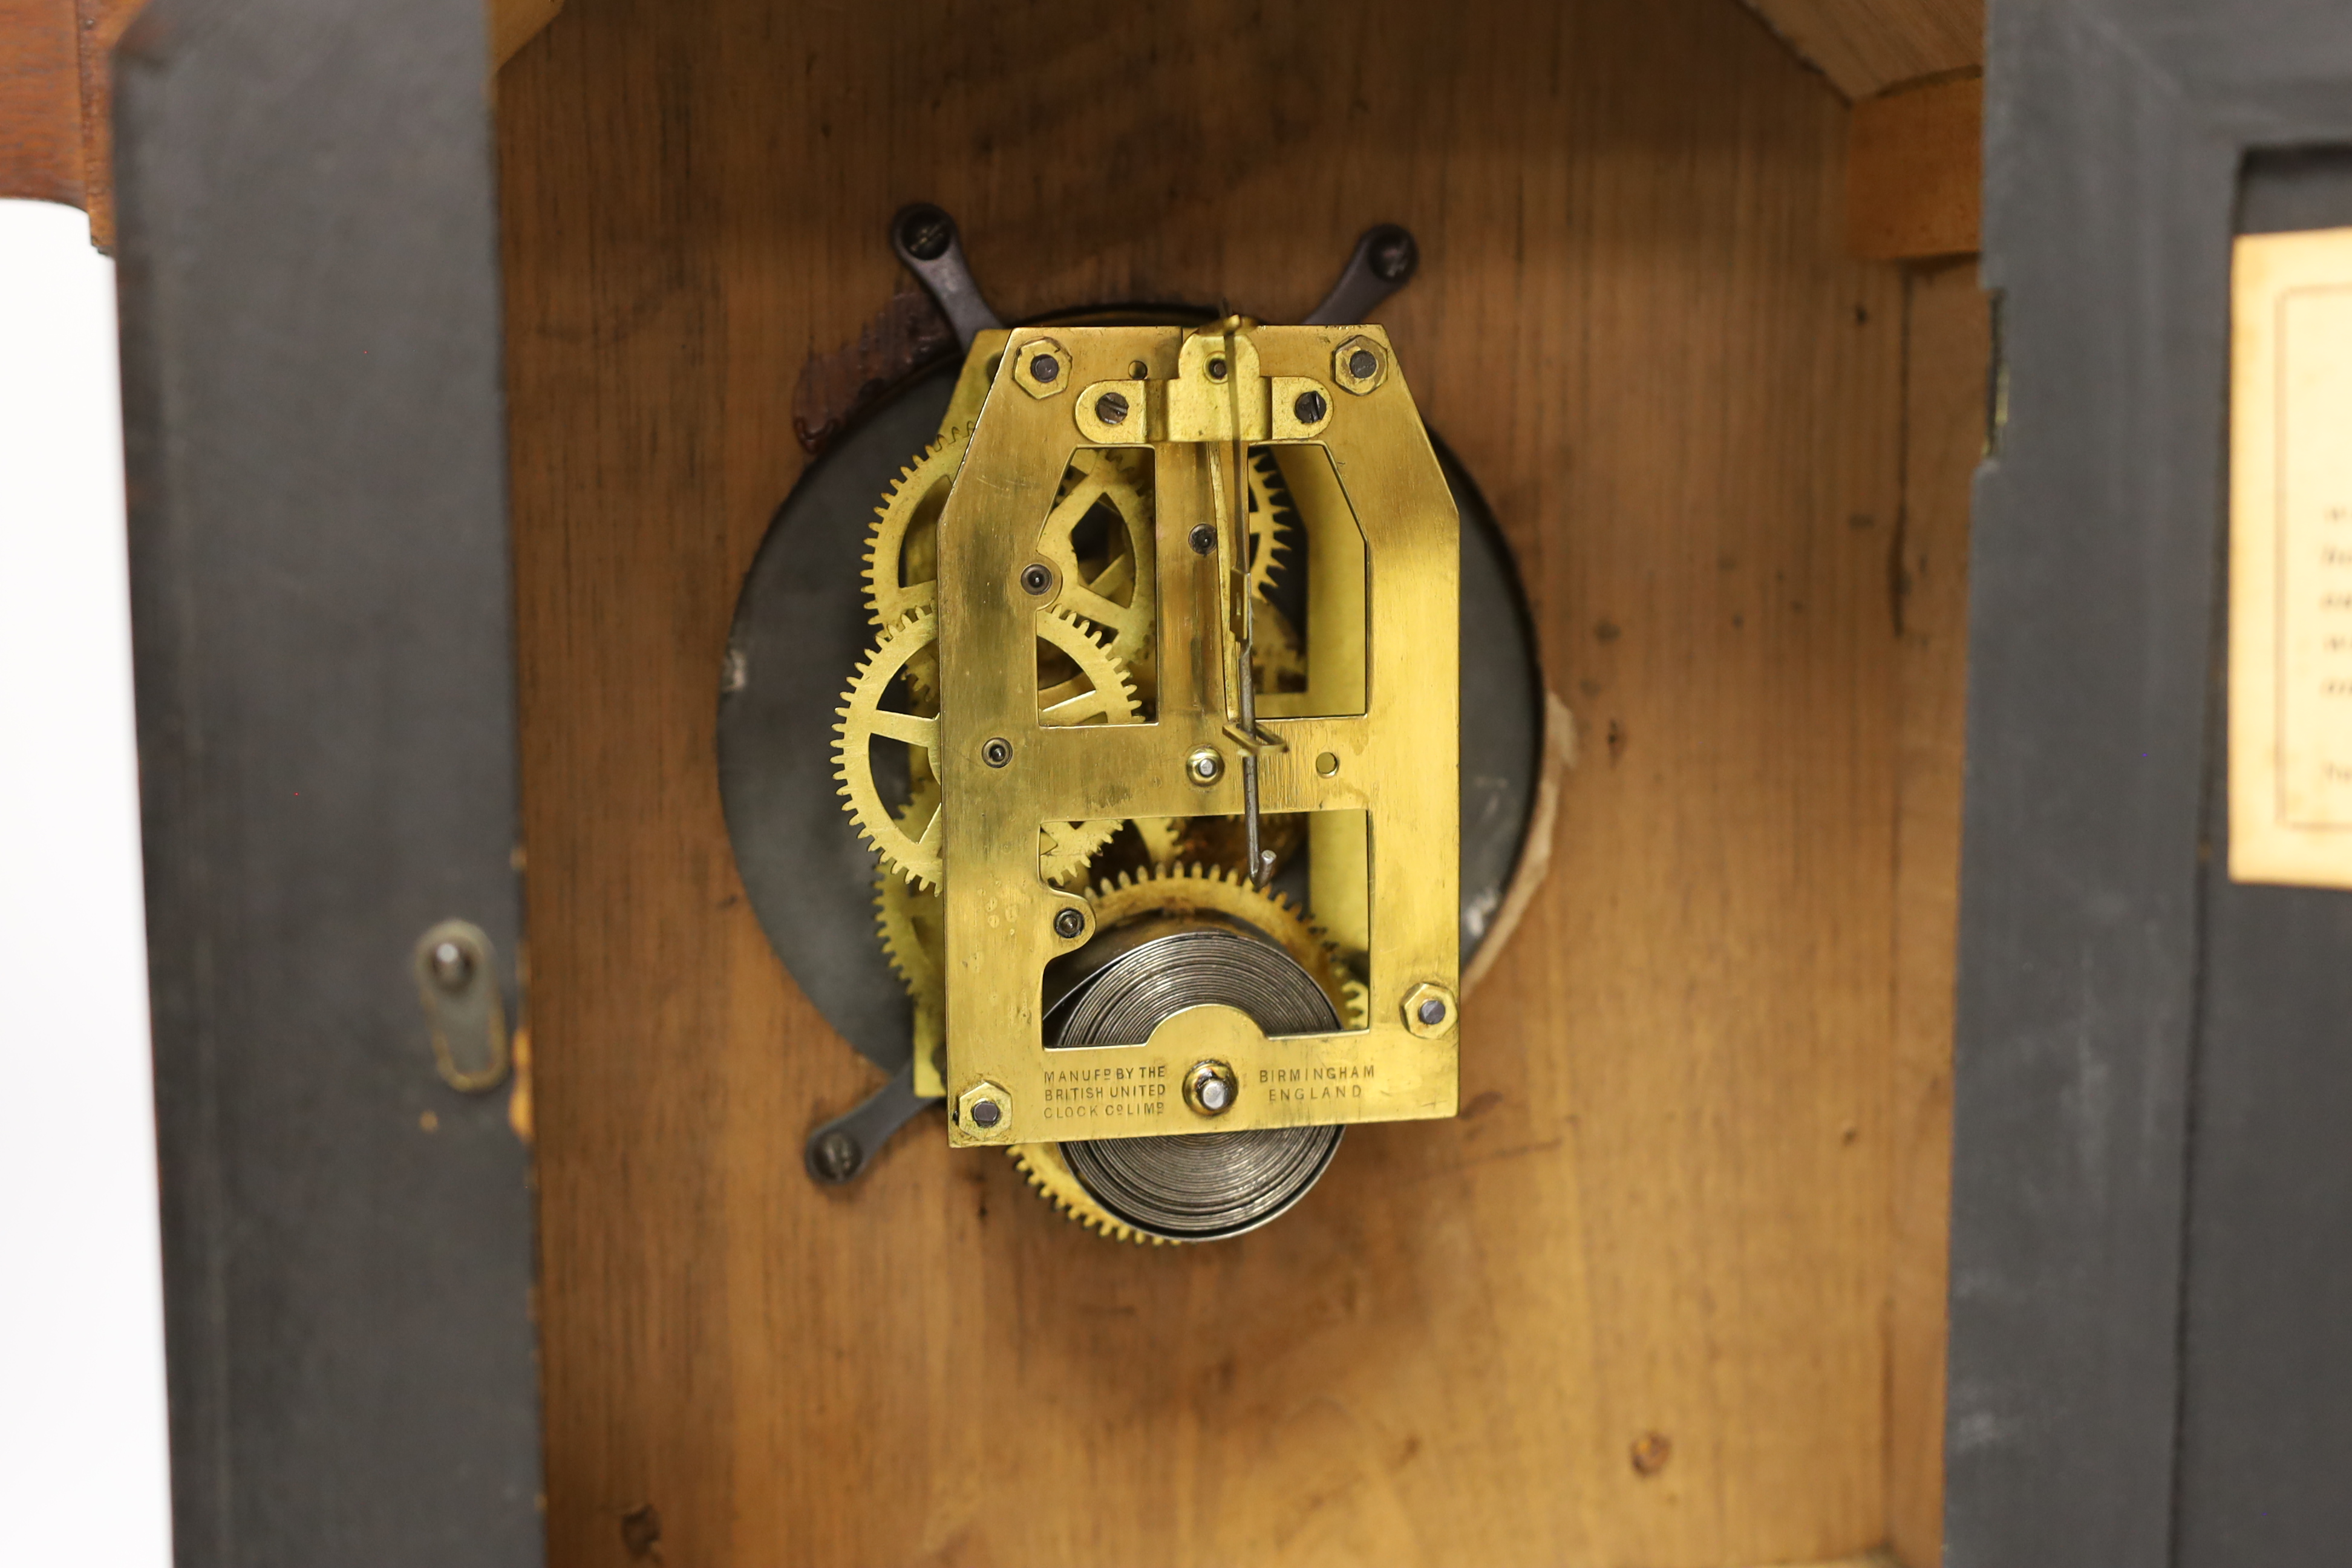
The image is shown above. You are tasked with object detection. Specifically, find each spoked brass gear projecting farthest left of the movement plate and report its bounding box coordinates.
[832,609,1141,886]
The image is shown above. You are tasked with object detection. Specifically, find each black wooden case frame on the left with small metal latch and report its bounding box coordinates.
[116,0,543,1568]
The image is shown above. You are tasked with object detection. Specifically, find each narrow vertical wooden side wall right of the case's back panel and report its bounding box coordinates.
[1886,256,1992,1568]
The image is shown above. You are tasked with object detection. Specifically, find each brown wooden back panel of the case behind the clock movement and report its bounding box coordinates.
[498,0,1903,1568]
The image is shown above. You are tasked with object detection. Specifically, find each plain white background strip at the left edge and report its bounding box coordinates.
[0,200,172,1568]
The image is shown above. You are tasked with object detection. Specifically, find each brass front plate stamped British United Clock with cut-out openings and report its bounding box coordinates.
[938,327,1460,1145]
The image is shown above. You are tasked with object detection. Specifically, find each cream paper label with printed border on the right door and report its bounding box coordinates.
[2230,228,2352,886]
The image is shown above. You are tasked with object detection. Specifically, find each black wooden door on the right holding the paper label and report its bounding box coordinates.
[1945,0,2352,1568]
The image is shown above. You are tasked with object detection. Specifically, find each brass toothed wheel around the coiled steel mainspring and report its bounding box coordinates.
[1007,865,1369,1246]
